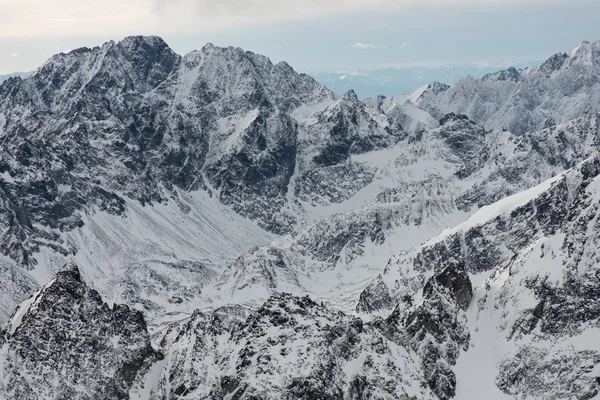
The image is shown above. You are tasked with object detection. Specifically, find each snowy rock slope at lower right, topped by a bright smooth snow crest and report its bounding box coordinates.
[361,156,600,399]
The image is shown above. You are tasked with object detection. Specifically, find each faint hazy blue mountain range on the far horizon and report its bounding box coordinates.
[309,62,541,99]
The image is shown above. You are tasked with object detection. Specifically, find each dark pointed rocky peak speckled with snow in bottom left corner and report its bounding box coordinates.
[0,266,160,399]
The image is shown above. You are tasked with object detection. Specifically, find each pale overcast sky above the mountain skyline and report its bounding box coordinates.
[0,0,600,73]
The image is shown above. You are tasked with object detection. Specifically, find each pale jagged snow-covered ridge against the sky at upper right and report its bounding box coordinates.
[398,41,600,134]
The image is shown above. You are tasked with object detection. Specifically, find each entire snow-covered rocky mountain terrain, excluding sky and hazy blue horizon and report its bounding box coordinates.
[0,37,600,399]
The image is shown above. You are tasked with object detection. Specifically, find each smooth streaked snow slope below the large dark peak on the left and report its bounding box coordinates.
[23,191,274,329]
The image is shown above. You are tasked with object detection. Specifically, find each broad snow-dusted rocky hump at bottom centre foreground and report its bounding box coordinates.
[152,293,431,400]
